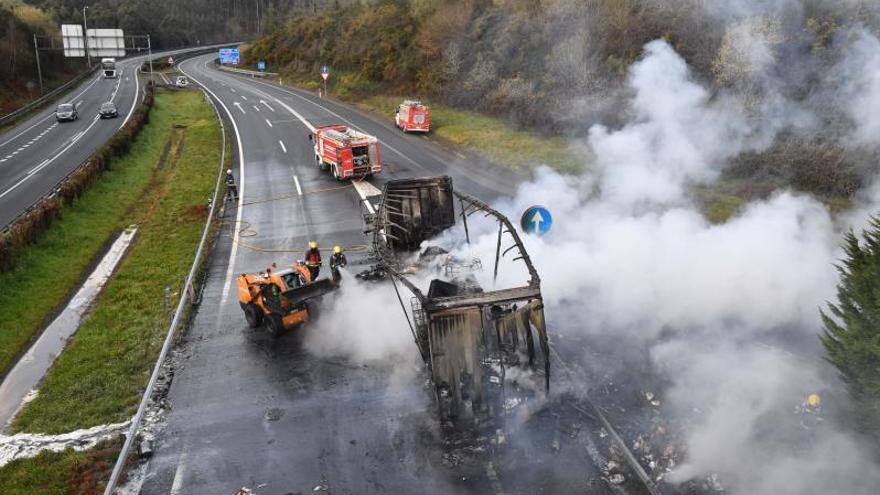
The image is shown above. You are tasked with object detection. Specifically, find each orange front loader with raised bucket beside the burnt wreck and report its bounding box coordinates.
[236,263,337,337]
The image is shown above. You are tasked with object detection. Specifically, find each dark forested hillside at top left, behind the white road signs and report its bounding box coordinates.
[0,0,324,114]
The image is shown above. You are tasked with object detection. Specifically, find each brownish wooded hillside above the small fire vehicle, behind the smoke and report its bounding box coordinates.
[245,0,880,203]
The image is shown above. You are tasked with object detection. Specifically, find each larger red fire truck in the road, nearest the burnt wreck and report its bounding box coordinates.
[309,124,382,180]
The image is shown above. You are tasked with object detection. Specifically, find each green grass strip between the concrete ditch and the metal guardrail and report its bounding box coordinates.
[4,91,220,433]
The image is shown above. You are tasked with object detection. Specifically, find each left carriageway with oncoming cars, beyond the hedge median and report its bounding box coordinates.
[0,46,229,229]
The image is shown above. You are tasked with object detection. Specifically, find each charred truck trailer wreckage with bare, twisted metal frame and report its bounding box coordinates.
[364,176,550,424]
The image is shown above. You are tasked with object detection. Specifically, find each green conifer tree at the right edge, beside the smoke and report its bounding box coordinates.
[821,217,880,438]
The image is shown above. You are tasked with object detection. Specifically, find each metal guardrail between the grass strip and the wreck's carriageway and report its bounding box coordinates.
[104,89,226,495]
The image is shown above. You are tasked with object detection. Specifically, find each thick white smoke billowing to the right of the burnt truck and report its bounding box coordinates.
[446,36,880,495]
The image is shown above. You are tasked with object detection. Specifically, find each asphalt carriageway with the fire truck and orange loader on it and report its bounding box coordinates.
[141,56,605,495]
